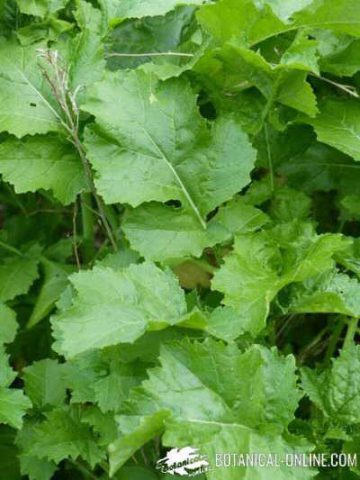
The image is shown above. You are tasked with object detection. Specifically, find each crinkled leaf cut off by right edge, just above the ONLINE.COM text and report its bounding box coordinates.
[302,345,360,425]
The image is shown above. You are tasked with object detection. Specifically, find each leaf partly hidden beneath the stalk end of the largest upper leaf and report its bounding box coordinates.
[123,199,268,261]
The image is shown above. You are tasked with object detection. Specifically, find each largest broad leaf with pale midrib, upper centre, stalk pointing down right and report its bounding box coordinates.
[83,72,255,228]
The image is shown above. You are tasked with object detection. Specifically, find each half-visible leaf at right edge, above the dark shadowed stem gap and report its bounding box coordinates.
[290,272,360,318]
